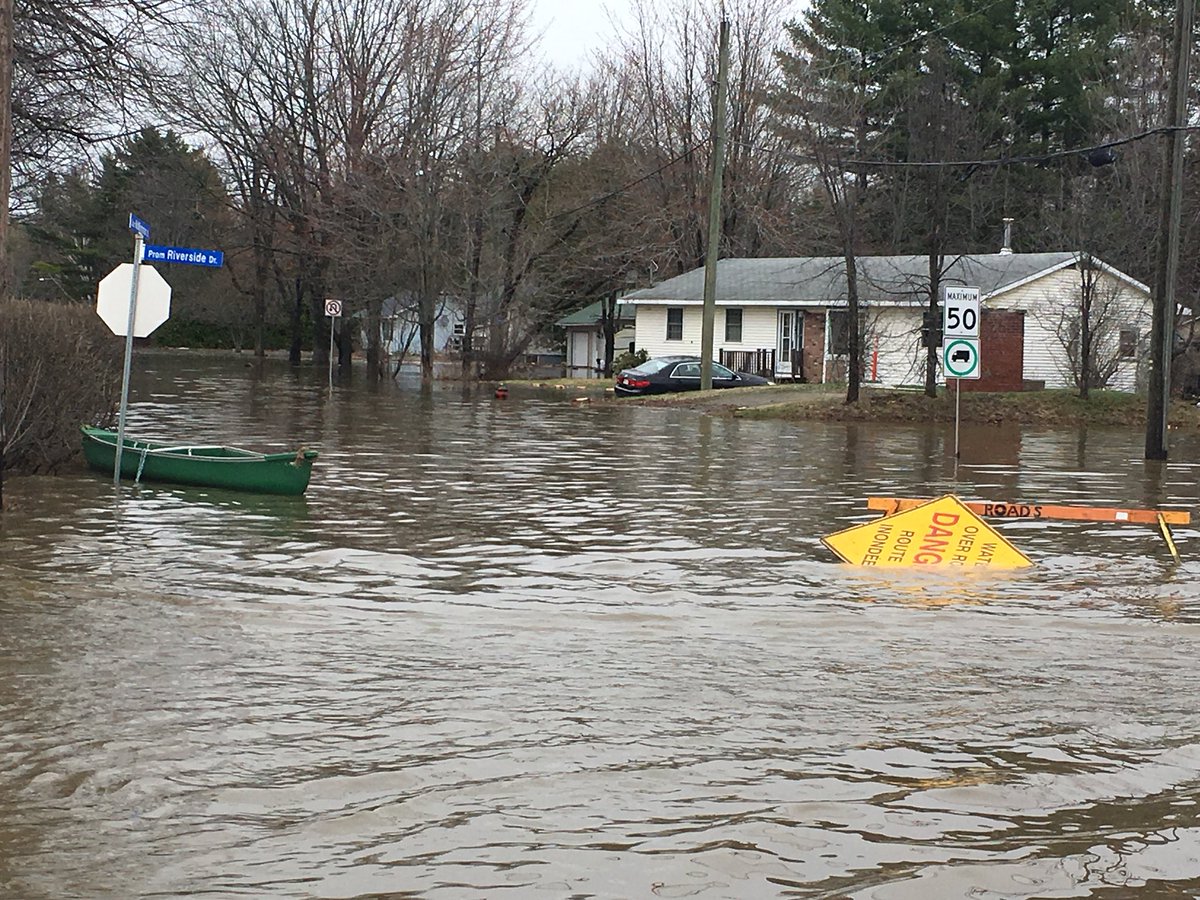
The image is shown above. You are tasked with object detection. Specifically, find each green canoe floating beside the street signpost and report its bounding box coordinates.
[83,425,317,494]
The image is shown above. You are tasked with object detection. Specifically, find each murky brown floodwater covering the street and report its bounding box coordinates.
[0,355,1200,900]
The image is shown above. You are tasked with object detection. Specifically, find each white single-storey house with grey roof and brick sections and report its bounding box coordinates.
[622,252,1151,390]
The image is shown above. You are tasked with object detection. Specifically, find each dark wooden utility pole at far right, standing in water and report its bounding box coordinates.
[1146,0,1195,460]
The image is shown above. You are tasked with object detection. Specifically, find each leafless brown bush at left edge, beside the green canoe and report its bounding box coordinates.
[0,300,125,473]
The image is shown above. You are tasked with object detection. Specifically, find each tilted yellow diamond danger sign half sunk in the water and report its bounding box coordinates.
[821,494,1033,569]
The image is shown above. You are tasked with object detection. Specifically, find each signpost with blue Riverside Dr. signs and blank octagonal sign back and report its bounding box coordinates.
[96,212,224,485]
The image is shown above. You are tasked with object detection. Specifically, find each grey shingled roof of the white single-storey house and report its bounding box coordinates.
[622,252,1145,305]
